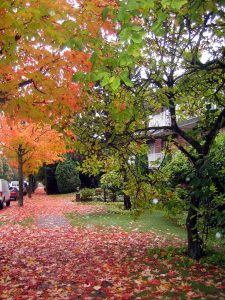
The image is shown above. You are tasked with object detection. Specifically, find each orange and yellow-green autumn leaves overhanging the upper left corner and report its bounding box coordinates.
[0,0,117,123]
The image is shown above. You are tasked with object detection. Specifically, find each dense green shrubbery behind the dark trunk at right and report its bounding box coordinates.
[161,133,225,240]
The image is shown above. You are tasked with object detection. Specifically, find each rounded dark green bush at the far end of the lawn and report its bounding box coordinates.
[55,158,80,193]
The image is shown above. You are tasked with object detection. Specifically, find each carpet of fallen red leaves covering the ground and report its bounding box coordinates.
[0,189,225,300]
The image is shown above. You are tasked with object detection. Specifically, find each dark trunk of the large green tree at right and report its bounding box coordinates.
[186,199,204,260]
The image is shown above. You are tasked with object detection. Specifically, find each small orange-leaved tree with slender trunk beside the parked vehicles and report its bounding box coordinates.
[0,118,66,206]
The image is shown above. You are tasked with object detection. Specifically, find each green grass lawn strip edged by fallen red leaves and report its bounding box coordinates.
[67,203,186,239]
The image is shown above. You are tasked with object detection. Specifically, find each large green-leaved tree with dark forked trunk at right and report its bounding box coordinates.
[71,0,225,259]
